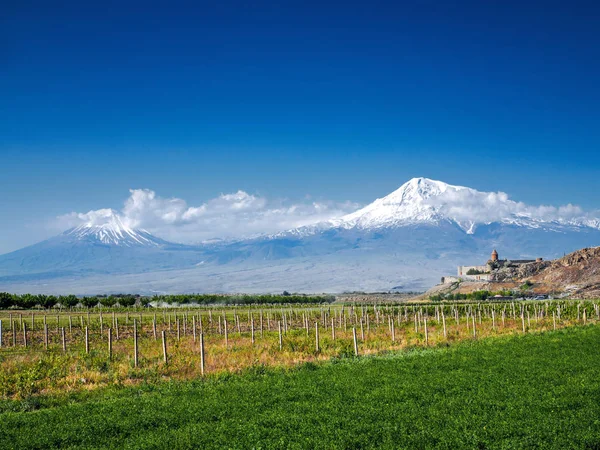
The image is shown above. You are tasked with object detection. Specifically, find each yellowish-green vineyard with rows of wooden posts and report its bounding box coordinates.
[0,300,600,399]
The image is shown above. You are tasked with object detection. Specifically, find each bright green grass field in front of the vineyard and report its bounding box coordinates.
[0,325,600,449]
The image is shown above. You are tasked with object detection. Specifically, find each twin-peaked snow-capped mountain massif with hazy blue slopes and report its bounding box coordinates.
[0,178,600,294]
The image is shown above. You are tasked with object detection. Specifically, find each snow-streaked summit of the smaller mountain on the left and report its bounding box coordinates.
[64,209,162,247]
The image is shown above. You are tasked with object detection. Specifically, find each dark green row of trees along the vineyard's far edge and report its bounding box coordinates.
[0,292,335,309]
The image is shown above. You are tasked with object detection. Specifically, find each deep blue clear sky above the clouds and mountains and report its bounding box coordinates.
[0,0,600,252]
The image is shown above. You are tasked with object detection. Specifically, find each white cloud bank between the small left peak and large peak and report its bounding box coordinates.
[58,189,360,243]
